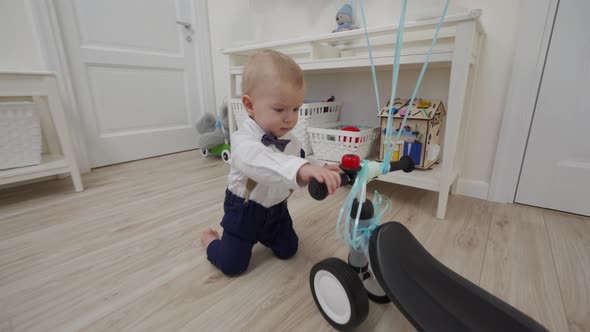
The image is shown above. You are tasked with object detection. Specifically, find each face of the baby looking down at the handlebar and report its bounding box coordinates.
[246,80,305,137]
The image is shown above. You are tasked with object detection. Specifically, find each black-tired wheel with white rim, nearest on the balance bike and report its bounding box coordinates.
[309,257,369,330]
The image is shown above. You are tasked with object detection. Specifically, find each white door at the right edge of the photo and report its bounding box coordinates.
[516,0,590,215]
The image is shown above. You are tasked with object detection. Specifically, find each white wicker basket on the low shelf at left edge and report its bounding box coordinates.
[0,102,41,170]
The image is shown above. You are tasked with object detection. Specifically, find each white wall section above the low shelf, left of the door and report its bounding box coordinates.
[0,0,45,71]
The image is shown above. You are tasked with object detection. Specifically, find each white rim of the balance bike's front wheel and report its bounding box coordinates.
[313,270,351,325]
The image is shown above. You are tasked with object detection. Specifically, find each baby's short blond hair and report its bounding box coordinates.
[242,50,305,95]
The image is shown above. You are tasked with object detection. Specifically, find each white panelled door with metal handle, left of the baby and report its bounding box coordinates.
[55,0,200,167]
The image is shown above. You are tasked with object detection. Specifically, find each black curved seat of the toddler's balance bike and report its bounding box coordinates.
[369,222,547,332]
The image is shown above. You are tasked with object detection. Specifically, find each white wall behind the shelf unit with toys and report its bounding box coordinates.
[208,0,520,198]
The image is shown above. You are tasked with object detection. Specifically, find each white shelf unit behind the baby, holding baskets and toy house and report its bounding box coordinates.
[223,10,483,219]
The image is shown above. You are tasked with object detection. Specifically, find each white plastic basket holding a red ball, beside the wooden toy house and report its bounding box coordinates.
[307,122,379,162]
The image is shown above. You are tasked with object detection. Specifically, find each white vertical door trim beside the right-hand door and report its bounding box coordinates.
[487,0,559,203]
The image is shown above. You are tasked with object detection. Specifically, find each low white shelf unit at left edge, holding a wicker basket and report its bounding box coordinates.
[0,72,84,192]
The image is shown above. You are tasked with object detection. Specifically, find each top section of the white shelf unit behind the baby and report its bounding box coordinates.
[223,10,481,76]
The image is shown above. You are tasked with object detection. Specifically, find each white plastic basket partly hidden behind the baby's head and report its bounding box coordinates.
[229,98,342,155]
